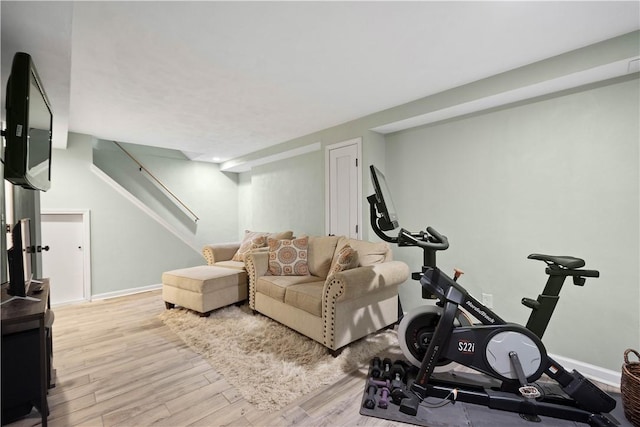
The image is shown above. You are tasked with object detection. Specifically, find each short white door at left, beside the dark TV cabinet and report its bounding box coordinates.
[41,213,90,305]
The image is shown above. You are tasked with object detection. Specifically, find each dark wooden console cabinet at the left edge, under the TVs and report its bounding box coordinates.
[0,279,54,427]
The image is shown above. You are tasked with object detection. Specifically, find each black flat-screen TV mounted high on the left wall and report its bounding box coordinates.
[4,52,53,191]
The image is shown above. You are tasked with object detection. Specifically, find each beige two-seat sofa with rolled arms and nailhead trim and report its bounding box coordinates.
[245,236,409,355]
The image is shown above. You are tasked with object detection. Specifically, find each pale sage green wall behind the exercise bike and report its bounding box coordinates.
[386,75,640,371]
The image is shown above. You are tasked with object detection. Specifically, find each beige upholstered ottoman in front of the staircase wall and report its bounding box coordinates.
[162,265,248,316]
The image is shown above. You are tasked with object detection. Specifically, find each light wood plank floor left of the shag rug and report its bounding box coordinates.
[3,291,406,427]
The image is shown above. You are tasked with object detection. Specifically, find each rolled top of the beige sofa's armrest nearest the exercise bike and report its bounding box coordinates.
[322,261,409,305]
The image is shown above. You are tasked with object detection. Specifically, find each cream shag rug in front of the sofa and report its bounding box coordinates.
[160,305,398,412]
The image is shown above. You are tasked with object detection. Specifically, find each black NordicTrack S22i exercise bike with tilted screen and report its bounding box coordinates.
[368,166,618,426]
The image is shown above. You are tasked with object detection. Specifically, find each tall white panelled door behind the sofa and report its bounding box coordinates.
[327,138,362,239]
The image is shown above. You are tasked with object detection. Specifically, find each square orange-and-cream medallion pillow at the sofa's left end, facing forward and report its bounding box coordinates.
[267,236,309,276]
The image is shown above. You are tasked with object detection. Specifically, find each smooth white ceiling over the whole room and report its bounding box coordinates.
[1,0,640,161]
